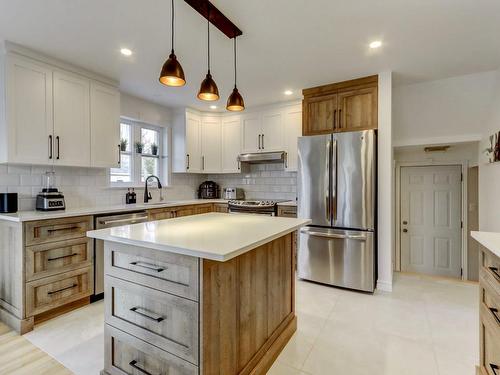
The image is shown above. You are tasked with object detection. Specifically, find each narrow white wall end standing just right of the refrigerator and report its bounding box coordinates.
[377,72,394,291]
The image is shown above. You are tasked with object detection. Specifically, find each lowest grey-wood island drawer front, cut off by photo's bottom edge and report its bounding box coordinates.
[104,324,199,375]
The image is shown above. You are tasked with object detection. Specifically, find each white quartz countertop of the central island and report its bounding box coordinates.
[87,213,311,262]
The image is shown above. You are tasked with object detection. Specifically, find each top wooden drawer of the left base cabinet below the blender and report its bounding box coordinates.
[25,216,92,246]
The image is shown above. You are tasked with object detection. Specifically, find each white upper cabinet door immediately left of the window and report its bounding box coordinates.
[90,82,120,168]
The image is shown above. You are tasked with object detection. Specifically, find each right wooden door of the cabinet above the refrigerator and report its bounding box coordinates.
[336,87,378,131]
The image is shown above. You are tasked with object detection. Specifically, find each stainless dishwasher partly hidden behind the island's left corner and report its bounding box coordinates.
[91,211,148,302]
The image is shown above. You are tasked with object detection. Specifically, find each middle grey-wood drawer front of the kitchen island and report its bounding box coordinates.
[105,276,198,364]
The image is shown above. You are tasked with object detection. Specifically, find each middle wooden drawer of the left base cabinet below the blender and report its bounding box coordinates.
[26,238,93,281]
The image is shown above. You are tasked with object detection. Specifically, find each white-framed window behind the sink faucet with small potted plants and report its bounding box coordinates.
[110,120,163,186]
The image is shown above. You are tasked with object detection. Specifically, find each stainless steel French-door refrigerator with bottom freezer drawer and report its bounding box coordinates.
[297,130,376,292]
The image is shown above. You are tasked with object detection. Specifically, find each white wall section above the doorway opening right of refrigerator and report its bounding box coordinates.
[393,71,496,146]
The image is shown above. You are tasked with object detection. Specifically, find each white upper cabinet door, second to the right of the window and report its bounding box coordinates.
[200,118,222,173]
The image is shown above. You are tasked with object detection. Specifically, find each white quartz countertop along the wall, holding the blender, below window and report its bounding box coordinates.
[0,199,227,222]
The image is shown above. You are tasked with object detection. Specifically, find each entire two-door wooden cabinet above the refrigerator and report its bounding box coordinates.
[302,76,378,135]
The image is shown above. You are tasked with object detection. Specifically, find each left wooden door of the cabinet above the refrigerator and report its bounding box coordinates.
[302,93,337,135]
